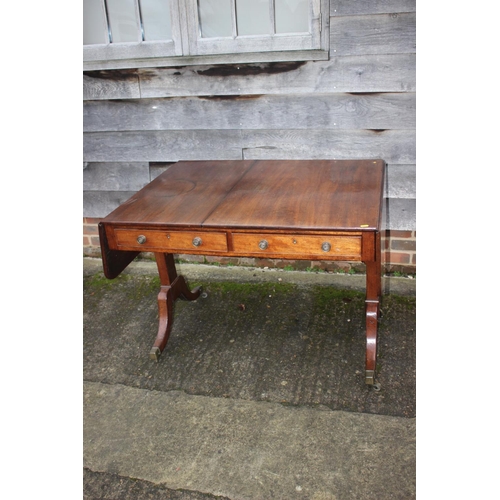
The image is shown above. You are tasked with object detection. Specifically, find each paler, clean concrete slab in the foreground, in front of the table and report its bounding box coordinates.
[84,382,415,500]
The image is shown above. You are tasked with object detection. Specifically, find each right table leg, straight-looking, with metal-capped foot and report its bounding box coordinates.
[365,233,382,385]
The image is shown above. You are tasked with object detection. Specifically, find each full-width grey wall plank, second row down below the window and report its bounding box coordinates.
[83,93,416,132]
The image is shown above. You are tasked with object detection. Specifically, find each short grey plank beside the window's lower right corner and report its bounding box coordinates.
[330,12,416,56]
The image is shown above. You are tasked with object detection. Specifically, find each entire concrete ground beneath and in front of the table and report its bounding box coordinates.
[83,259,416,500]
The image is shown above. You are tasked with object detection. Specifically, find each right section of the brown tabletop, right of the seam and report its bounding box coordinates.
[203,160,384,230]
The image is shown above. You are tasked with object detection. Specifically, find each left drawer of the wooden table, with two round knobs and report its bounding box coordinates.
[114,229,227,253]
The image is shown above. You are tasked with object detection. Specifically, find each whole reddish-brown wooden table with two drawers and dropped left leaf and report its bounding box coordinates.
[99,160,385,385]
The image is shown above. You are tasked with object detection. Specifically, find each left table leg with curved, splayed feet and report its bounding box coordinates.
[149,253,201,361]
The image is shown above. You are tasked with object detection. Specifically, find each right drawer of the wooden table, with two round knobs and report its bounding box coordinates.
[233,233,361,260]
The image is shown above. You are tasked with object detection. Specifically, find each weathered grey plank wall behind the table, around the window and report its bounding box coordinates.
[83,0,416,231]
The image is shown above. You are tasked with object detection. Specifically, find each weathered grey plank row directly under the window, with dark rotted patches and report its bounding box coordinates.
[84,54,416,100]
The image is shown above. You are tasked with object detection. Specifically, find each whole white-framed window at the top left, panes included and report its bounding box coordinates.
[83,0,329,69]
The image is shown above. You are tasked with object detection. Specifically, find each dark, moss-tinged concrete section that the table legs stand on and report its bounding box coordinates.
[84,273,416,416]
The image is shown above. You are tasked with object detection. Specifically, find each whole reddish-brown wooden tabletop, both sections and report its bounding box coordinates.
[103,160,385,231]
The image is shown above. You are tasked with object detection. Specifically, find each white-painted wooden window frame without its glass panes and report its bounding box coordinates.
[83,0,330,70]
